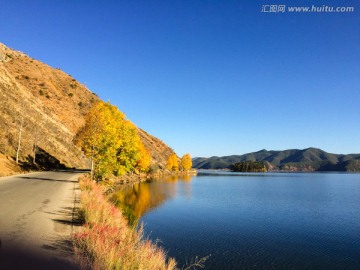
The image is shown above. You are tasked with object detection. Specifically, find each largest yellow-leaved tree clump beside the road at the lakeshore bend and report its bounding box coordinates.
[75,102,150,179]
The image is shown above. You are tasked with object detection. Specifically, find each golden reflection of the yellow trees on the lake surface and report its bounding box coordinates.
[110,175,191,225]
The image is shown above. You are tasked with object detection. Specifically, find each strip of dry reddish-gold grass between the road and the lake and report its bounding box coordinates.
[75,178,176,270]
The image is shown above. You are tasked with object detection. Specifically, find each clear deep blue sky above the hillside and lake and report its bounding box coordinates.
[0,0,360,157]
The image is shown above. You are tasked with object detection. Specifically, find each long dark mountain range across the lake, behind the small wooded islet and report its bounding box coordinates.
[193,148,360,172]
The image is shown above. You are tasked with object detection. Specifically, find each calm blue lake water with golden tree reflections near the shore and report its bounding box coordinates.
[114,173,360,269]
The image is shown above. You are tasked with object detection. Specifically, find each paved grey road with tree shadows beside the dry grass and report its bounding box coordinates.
[0,171,82,270]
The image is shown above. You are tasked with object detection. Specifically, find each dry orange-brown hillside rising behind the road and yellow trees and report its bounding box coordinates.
[0,43,173,172]
